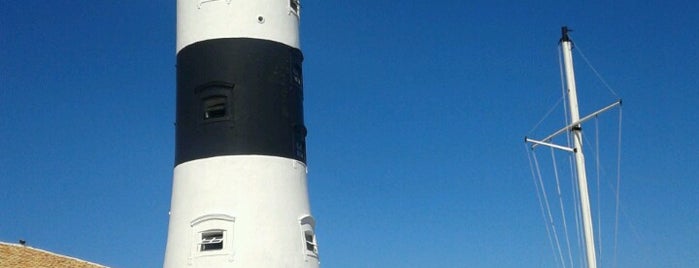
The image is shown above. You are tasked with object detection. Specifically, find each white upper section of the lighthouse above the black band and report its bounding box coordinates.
[177,0,300,52]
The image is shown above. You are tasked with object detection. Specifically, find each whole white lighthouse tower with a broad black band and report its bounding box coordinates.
[164,0,320,268]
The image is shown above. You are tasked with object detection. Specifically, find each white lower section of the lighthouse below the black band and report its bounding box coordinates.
[164,155,319,268]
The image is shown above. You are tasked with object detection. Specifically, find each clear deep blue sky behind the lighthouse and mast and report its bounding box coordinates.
[0,0,699,268]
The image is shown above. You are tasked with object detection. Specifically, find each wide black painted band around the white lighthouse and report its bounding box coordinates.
[175,38,306,165]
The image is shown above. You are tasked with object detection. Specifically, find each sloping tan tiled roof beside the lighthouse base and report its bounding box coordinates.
[0,242,106,268]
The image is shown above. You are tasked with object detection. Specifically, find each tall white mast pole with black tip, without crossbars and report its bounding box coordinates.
[561,26,597,268]
